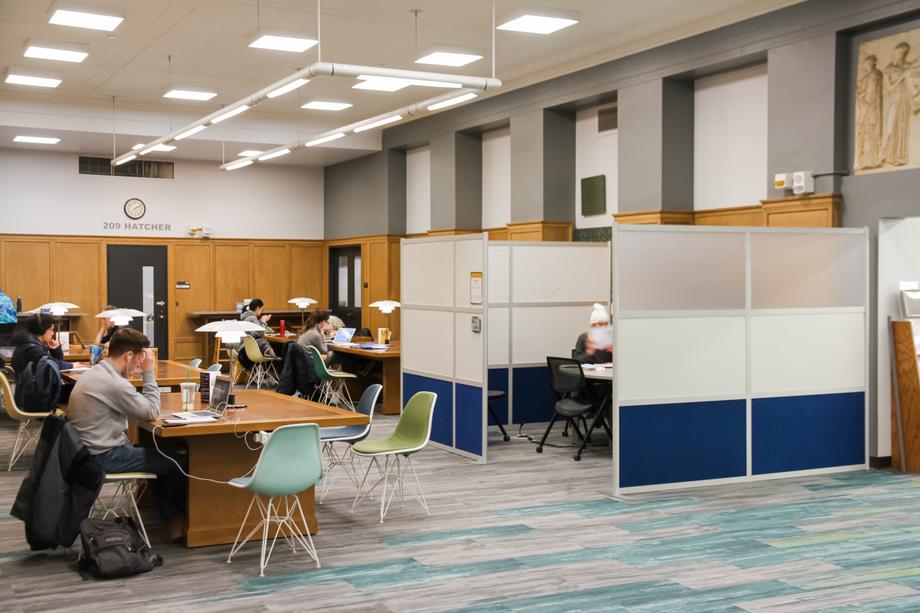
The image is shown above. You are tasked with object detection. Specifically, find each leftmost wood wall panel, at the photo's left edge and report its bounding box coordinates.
[3,238,52,310]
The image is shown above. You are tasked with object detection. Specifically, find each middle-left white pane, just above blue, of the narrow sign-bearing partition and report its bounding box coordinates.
[400,309,454,378]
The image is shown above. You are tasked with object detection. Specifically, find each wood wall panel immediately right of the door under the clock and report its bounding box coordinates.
[169,243,213,361]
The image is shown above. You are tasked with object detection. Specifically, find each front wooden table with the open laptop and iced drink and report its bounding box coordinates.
[139,390,368,547]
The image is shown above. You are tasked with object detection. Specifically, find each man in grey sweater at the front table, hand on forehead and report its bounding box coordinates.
[67,328,187,541]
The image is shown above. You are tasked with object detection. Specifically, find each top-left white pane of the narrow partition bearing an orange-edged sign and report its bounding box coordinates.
[401,241,454,307]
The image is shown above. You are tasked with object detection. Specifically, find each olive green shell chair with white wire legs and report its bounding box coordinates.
[351,392,438,523]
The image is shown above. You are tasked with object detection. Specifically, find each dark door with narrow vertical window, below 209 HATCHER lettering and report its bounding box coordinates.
[106,245,169,360]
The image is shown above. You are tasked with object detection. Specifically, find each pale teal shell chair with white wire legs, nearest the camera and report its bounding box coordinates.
[227,424,323,577]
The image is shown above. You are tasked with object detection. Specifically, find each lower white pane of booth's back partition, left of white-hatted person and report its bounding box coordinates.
[511,305,591,364]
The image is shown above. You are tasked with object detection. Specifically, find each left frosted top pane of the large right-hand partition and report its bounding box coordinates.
[617,230,745,312]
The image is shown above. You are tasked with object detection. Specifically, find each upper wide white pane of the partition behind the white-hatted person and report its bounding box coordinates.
[510,243,610,305]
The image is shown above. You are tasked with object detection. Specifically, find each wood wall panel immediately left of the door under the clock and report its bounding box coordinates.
[51,240,105,343]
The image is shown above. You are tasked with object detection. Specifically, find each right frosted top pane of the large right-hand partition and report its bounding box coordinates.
[751,232,866,309]
